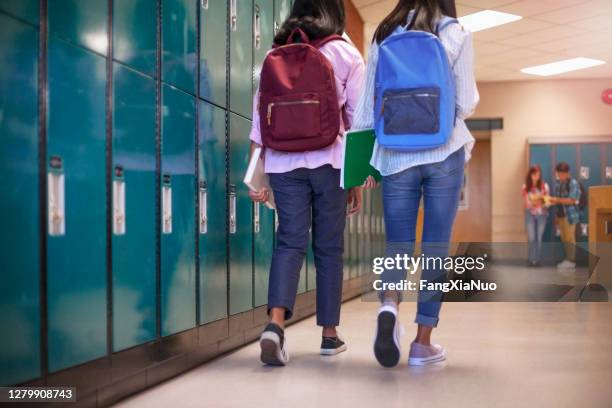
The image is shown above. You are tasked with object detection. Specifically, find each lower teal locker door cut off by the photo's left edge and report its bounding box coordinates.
[0,13,39,385]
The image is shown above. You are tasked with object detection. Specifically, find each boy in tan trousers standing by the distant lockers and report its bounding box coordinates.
[551,162,581,269]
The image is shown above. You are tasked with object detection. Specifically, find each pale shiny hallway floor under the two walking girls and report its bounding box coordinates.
[119,299,612,408]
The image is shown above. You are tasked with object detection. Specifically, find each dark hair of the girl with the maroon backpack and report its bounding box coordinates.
[274,0,346,45]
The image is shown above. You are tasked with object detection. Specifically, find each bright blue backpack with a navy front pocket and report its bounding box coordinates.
[374,17,458,151]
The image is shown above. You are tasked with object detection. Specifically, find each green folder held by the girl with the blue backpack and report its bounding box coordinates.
[340,129,382,190]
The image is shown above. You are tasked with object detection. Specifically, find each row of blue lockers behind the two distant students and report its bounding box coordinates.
[529,140,612,244]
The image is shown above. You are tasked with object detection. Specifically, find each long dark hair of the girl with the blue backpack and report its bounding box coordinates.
[373,0,457,44]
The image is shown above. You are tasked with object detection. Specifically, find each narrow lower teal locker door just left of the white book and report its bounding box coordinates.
[228,113,253,314]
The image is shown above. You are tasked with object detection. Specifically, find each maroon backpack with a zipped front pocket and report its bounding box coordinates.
[259,28,344,152]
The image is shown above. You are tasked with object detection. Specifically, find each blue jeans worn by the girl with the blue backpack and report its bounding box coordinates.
[382,148,465,327]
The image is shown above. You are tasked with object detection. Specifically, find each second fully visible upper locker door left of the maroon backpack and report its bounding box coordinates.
[200,0,228,107]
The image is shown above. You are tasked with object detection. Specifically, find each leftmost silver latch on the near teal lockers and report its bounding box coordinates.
[47,156,66,236]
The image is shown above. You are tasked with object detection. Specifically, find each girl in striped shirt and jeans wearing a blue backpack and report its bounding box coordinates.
[353,0,479,367]
